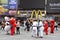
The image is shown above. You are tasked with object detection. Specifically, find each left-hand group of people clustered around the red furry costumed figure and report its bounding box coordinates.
[1,16,20,35]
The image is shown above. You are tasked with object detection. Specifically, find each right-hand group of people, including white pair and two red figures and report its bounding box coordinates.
[24,19,58,38]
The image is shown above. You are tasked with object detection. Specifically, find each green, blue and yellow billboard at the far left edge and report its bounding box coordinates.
[0,0,8,15]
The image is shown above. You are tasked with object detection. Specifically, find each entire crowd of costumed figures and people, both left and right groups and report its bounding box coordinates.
[2,16,58,38]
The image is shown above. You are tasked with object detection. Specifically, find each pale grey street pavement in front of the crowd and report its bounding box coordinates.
[0,28,60,40]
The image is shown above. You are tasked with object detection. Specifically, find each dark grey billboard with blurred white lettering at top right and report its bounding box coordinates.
[46,0,60,13]
